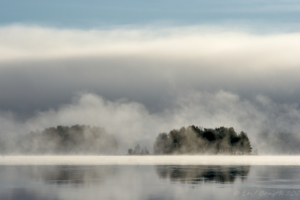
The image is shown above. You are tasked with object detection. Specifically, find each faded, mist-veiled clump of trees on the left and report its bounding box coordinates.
[1,125,118,154]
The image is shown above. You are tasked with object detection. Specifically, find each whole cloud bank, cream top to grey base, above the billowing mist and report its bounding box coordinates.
[0,25,300,118]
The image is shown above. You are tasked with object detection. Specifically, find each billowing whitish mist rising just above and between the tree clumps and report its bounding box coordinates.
[0,91,300,153]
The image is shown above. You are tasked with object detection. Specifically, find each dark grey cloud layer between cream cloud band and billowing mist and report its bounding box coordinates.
[0,54,300,116]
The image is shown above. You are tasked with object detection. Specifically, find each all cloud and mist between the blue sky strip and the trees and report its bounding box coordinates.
[0,25,300,154]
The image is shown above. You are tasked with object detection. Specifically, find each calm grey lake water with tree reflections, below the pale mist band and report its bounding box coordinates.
[0,165,300,200]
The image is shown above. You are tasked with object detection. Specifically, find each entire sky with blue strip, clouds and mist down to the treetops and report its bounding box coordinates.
[0,0,300,153]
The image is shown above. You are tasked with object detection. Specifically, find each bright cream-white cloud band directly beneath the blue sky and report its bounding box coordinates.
[0,25,300,72]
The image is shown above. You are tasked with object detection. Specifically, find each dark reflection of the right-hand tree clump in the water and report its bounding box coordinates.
[156,165,250,184]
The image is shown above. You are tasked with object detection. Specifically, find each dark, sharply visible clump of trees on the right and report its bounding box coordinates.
[154,126,252,154]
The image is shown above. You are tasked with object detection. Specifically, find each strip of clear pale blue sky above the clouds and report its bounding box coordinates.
[0,0,300,30]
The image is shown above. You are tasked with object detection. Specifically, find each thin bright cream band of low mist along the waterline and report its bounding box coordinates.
[0,155,300,165]
